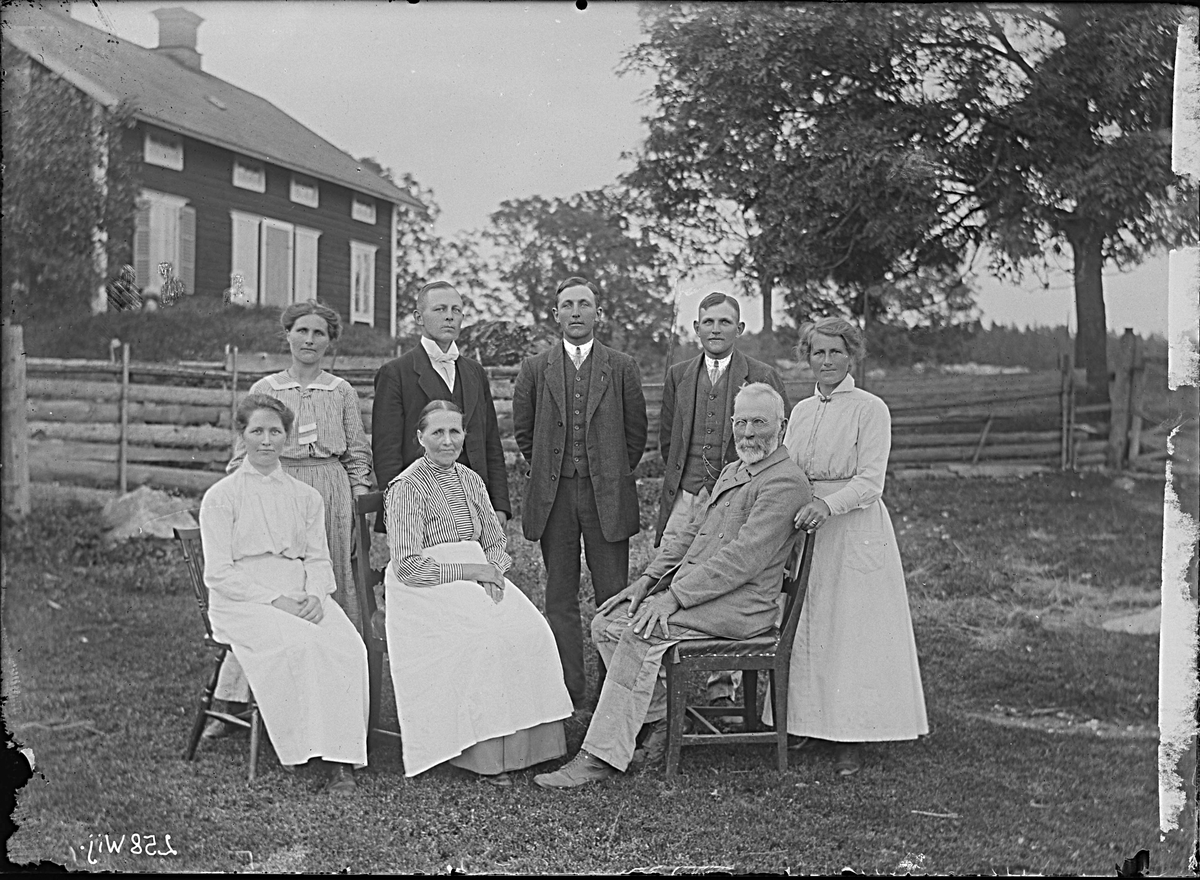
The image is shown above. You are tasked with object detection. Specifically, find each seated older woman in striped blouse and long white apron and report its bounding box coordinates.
[384,400,572,785]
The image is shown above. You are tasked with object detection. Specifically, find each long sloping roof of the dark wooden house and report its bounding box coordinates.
[4,4,425,210]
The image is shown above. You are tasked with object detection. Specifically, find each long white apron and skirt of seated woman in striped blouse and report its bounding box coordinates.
[384,541,572,777]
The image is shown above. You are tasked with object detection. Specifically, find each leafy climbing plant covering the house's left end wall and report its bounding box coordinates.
[2,49,144,321]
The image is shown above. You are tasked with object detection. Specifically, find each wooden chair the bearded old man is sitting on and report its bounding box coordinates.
[664,532,816,779]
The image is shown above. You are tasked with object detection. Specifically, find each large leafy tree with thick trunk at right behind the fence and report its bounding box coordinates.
[629,4,1195,394]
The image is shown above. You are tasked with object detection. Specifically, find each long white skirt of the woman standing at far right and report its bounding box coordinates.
[763,484,929,742]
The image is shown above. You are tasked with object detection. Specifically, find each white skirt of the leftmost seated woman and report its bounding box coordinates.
[209,556,370,766]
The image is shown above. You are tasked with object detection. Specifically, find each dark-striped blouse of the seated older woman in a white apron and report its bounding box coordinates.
[385,457,512,587]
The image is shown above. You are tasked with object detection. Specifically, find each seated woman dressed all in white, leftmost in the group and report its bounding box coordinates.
[200,394,368,794]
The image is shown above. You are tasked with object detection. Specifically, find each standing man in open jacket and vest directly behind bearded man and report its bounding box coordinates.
[654,293,791,707]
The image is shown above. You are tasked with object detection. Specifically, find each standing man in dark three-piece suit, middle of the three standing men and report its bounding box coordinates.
[512,276,647,708]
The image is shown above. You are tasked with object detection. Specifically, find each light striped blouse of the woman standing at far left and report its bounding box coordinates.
[226,370,371,489]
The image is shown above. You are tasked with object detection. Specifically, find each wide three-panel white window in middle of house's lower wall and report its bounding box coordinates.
[229,211,320,307]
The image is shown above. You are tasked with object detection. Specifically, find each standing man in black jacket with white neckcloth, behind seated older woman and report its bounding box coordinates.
[371,281,512,518]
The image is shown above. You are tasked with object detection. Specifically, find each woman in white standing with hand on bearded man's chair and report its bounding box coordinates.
[768,318,929,777]
